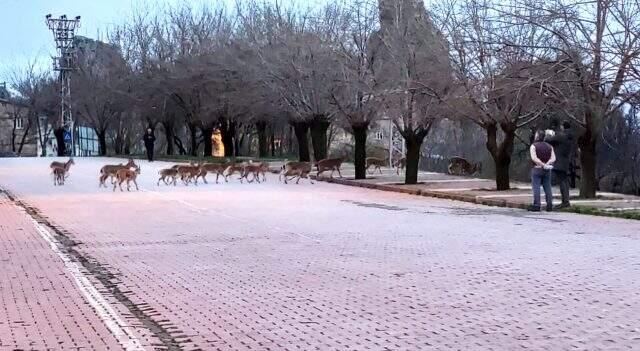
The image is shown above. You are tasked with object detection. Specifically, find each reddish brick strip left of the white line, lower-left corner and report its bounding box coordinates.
[0,193,146,350]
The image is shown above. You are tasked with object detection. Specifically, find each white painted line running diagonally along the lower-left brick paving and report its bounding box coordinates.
[14,204,145,351]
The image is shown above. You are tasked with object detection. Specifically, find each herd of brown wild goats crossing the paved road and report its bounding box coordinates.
[50,157,480,191]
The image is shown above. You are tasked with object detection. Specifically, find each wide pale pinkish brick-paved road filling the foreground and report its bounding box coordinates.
[0,159,640,350]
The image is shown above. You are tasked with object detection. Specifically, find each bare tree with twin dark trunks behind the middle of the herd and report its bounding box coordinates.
[239,2,343,161]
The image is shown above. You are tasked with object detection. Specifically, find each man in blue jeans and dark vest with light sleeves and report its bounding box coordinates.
[529,130,556,212]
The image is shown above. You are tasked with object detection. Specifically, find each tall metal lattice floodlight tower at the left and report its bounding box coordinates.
[45,14,80,156]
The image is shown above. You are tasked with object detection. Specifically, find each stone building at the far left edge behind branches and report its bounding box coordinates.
[0,83,38,156]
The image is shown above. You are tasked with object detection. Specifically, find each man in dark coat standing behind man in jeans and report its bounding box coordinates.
[545,121,576,208]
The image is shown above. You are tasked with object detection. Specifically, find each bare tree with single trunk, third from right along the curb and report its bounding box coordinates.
[373,0,453,184]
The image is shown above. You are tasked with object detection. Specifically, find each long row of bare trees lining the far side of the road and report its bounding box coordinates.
[7,0,640,197]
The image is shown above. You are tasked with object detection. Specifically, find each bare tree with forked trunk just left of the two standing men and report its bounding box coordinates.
[434,0,553,190]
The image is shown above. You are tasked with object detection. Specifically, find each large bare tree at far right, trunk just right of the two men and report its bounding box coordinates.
[496,0,640,198]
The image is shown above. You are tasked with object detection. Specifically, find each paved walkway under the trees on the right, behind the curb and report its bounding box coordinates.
[320,164,640,212]
